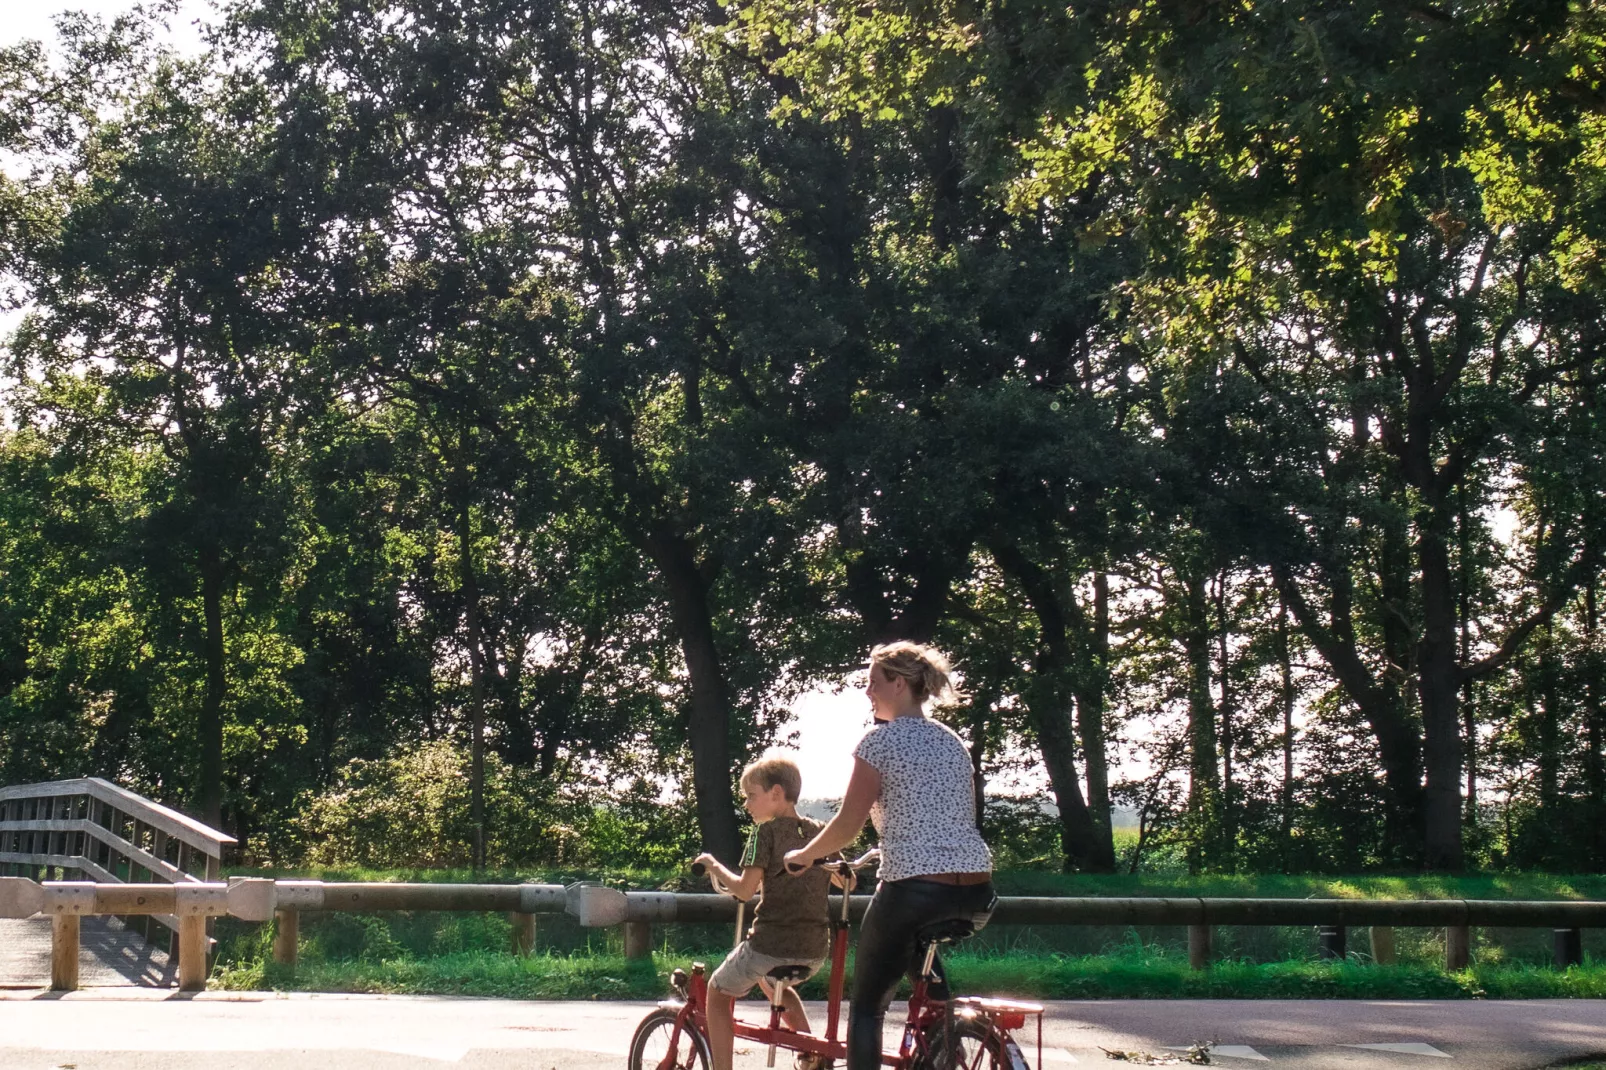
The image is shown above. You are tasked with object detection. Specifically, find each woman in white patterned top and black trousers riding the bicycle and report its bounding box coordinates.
[785,643,993,1070]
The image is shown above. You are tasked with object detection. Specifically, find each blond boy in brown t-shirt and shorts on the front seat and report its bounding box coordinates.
[697,757,835,1070]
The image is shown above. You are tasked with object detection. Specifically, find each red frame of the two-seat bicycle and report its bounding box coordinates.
[657,863,1042,1070]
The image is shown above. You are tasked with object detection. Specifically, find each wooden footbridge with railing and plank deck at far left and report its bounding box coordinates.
[0,778,234,988]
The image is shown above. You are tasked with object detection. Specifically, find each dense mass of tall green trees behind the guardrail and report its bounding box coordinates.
[0,0,1606,873]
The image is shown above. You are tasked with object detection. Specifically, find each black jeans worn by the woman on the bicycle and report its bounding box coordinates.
[848,877,993,1070]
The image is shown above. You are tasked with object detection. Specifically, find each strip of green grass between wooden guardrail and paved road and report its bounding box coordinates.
[212,951,1606,999]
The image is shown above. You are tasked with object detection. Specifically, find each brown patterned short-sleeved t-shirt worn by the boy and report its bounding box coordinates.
[742,818,830,962]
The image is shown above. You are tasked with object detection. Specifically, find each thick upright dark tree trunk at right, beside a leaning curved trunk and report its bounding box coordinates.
[1416,506,1463,872]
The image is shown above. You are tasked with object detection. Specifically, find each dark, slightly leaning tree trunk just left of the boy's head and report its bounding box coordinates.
[647,529,742,866]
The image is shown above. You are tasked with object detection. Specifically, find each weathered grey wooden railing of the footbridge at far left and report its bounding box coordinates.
[0,776,234,948]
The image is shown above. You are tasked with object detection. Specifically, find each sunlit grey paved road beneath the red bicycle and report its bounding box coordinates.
[0,988,1606,1070]
